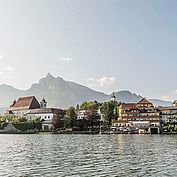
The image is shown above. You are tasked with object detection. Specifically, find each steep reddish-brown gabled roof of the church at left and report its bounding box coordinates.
[9,96,40,111]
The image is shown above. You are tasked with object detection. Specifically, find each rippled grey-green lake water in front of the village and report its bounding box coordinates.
[0,135,177,177]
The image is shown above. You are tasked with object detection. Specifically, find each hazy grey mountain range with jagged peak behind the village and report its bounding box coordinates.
[0,74,172,108]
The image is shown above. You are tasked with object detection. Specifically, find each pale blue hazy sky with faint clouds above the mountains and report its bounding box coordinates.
[0,0,177,100]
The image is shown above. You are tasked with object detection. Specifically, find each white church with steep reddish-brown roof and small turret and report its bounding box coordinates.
[7,96,64,131]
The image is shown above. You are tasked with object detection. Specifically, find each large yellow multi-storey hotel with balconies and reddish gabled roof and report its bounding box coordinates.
[112,98,161,133]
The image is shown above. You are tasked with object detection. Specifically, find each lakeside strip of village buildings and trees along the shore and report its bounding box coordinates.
[0,93,177,134]
